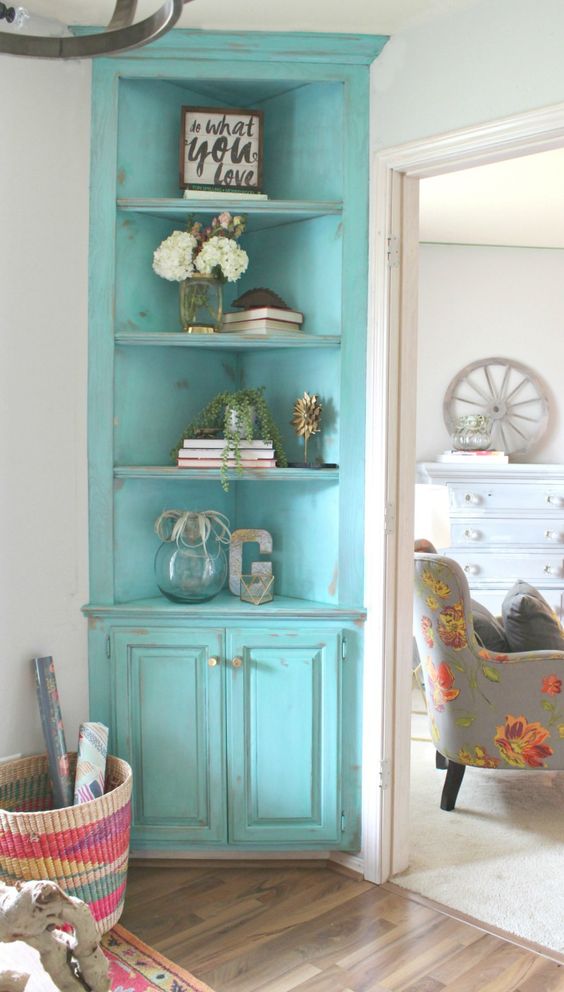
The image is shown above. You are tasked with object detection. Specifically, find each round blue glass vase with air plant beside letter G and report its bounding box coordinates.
[155,510,229,603]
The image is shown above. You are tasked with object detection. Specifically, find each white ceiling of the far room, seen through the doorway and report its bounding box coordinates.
[420,149,564,248]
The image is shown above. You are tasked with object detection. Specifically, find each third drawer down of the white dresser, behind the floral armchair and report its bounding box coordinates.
[445,548,564,588]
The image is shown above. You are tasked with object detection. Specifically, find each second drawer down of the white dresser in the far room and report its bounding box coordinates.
[450,512,564,551]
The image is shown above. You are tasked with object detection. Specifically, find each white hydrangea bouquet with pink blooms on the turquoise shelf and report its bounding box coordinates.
[153,211,249,282]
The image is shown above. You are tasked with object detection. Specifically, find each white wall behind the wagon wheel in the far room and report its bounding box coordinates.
[417,245,564,463]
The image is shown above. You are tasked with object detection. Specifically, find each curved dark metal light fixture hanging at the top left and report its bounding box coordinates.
[0,0,191,59]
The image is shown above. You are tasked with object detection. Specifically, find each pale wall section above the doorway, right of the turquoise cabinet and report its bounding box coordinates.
[373,0,564,148]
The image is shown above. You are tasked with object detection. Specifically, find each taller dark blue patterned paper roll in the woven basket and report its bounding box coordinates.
[33,656,73,809]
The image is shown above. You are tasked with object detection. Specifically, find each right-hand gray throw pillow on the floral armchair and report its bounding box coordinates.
[501,579,564,651]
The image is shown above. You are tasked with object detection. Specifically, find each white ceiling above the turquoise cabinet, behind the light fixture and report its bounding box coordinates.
[11,0,480,34]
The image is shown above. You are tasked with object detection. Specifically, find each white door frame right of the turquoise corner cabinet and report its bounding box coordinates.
[363,97,564,883]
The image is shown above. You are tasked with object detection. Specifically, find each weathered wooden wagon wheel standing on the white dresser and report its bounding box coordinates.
[443,358,549,455]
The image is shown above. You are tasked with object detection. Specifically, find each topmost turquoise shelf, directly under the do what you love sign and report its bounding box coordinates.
[117,197,343,231]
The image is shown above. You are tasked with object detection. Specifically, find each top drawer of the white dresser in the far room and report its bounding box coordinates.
[448,480,564,513]
